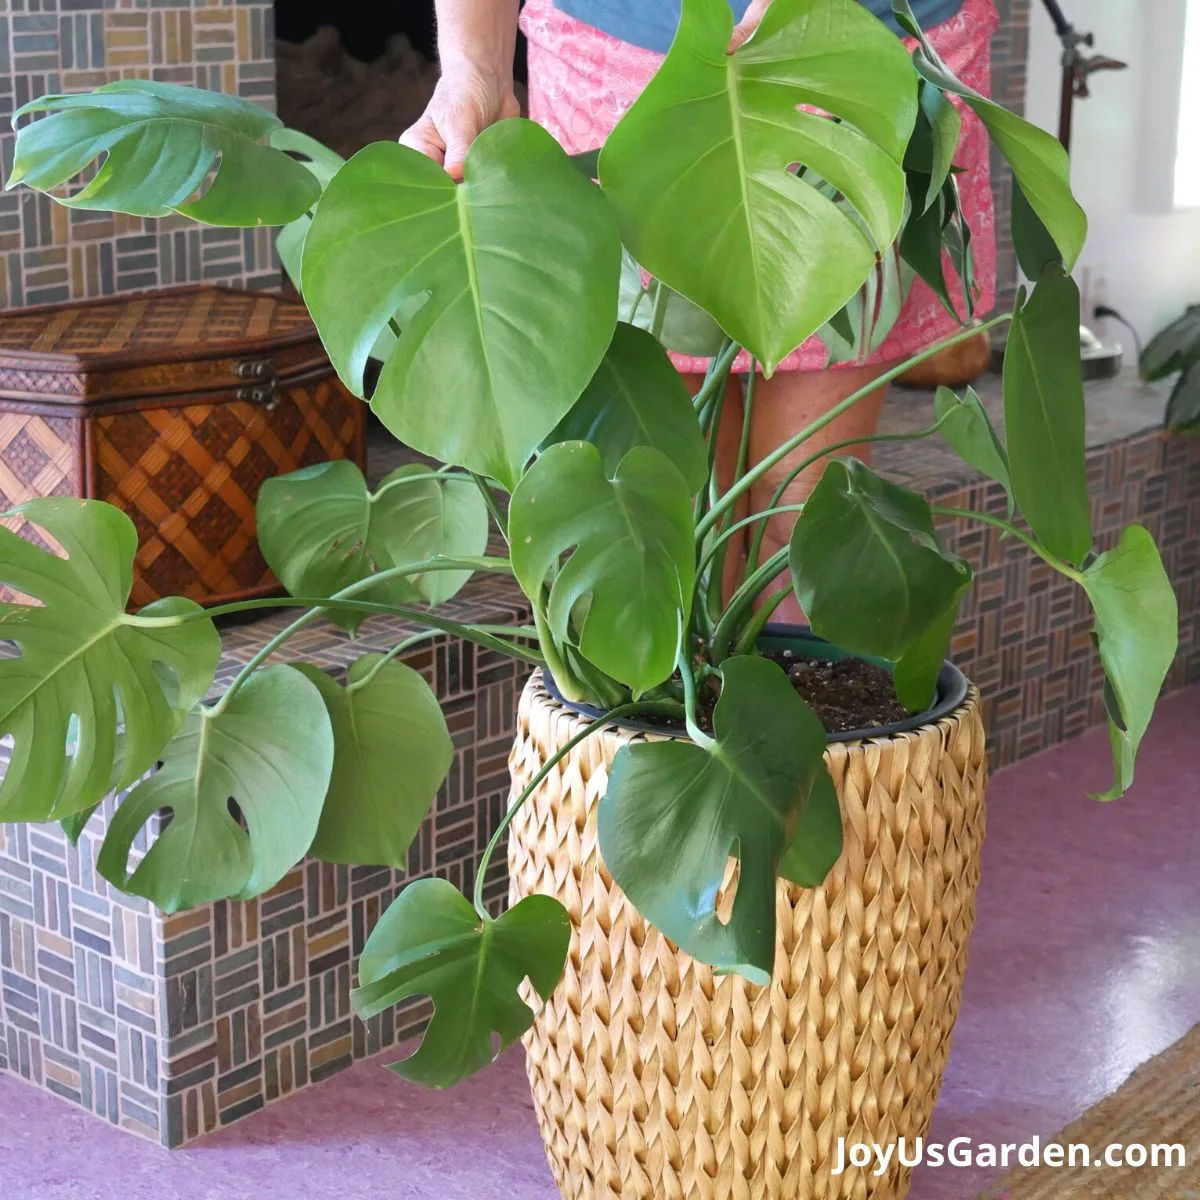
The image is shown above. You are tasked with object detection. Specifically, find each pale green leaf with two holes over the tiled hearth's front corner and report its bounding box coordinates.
[96,666,334,912]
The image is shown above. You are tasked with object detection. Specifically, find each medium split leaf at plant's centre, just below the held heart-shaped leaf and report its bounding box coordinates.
[509,442,696,691]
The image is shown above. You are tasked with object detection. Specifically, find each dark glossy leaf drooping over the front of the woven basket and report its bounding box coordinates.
[599,655,840,985]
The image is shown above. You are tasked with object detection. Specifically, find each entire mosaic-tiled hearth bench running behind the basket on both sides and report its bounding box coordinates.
[0,380,1200,1146]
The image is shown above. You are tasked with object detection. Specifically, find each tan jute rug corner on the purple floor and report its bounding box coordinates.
[978,1025,1200,1200]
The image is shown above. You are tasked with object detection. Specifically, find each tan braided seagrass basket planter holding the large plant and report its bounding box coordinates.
[509,672,986,1200]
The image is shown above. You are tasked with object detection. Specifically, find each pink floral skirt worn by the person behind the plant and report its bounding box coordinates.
[521,0,1000,372]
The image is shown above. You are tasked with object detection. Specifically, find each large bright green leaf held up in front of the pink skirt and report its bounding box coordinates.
[600,0,917,373]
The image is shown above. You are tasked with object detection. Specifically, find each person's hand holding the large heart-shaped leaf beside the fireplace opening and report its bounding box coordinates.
[400,62,521,179]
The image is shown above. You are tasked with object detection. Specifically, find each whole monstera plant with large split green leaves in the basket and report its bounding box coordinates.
[0,0,1177,1085]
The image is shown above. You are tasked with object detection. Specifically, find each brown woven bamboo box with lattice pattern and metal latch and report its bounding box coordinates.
[0,287,364,606]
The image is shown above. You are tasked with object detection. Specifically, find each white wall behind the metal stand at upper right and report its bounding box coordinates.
[1026,0,1200,343]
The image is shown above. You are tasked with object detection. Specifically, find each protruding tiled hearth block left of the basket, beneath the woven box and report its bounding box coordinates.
[0,571,528,1146]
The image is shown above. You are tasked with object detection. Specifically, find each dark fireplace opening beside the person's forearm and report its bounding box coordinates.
[275,0,524,157]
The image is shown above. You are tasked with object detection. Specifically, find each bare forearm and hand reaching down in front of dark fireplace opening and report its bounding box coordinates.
[400,0,520,179]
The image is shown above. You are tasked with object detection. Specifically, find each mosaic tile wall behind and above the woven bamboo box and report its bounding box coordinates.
[0,0,278,308]
